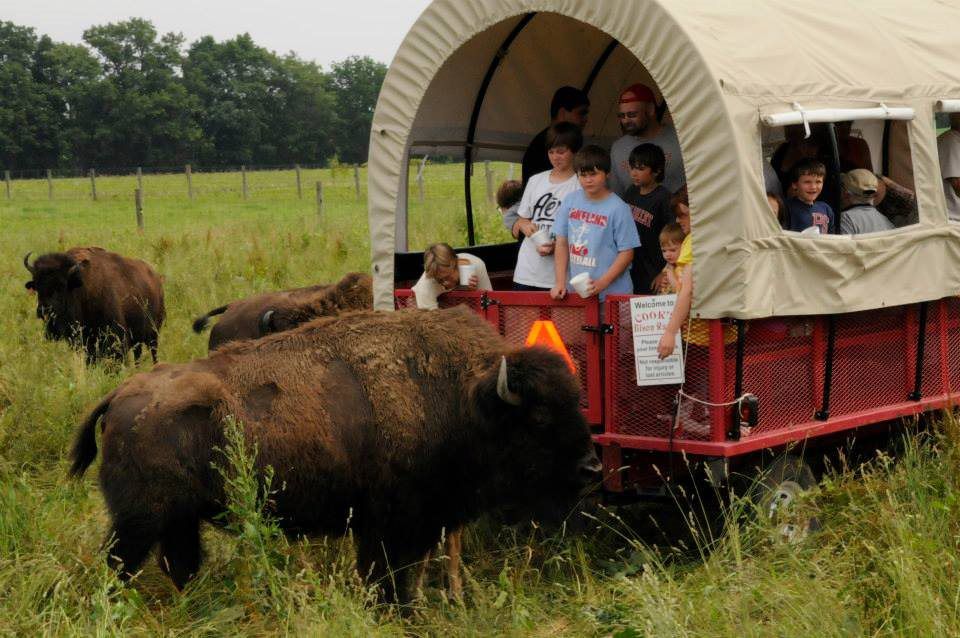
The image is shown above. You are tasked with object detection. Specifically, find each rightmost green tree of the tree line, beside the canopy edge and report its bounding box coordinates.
[330,56,387,163]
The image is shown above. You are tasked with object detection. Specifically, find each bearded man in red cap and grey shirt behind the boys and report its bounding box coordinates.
[610,84,686,197]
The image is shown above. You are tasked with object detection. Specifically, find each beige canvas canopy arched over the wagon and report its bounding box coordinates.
[369,0,960,318]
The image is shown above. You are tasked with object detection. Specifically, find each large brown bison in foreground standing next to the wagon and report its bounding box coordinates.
[71,308,600,601]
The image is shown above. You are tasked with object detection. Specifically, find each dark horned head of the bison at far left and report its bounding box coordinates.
[23,253,89,339]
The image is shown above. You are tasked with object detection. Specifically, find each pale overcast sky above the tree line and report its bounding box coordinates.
[0,0,430,69]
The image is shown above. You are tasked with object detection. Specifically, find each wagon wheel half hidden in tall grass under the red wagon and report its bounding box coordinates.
[752,454,820,543]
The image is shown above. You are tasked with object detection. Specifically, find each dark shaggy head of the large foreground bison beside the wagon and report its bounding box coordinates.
[472,348,601,520]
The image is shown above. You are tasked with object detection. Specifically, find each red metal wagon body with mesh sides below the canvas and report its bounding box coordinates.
[395,289,960,492]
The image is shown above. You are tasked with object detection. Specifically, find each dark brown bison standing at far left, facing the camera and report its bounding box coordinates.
[23,247,164,363]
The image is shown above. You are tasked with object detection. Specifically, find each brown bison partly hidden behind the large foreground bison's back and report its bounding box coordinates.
[193,272,373,350]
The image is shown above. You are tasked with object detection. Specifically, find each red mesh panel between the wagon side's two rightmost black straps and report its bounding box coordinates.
[830,306,913,416]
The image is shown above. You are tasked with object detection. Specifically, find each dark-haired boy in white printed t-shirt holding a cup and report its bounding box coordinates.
[513,122,583,292]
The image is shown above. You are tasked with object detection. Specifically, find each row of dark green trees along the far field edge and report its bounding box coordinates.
[0,18,386,170]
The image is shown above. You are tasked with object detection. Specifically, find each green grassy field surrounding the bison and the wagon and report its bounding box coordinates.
[0,165,960,638]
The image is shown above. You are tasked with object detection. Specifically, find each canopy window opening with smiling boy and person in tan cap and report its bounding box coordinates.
[762,109,919,235]
